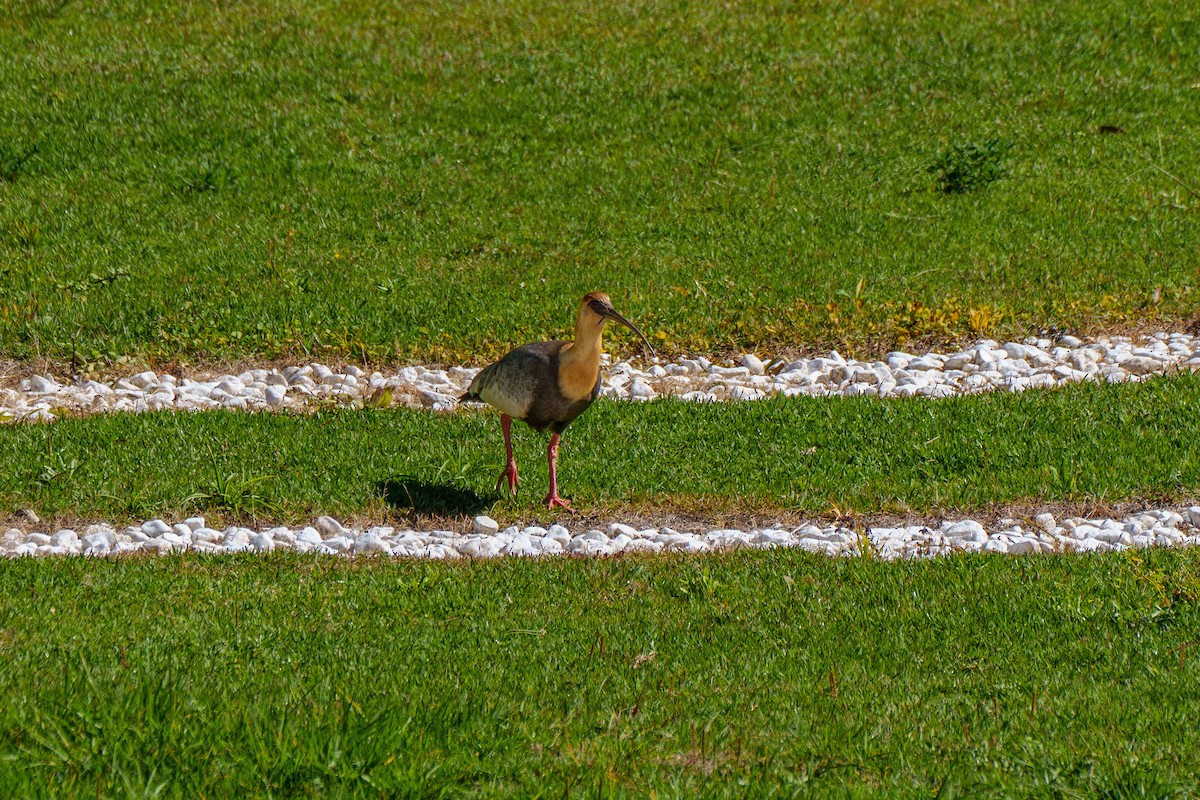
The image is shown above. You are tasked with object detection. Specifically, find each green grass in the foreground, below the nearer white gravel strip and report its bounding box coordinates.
[0,551,1200,799]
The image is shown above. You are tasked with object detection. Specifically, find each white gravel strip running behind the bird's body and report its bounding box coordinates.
[0,332,1200,421]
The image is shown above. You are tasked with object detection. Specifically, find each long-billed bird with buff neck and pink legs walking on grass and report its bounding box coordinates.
[458,291,654,510]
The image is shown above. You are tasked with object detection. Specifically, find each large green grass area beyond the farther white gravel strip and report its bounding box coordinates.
[0,0,1200,363]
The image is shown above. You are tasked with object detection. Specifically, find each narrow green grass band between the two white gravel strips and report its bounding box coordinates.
[0,374,1200,522]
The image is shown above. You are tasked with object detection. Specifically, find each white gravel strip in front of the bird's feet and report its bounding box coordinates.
[0,506,1200,560]
